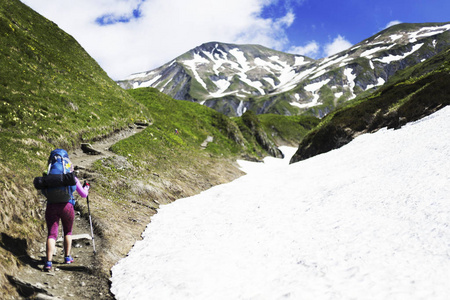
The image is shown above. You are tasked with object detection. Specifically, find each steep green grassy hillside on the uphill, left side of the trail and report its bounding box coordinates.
[0,0,150,292]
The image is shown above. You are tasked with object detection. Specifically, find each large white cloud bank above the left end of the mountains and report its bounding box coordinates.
[22,0,295,79]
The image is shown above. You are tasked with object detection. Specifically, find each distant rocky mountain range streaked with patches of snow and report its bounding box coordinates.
[118,23,450,117]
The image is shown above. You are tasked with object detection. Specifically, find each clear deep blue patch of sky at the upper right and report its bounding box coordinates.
[268,0,450,58]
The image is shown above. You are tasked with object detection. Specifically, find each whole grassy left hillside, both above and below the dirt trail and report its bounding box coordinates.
[0,0,316,298]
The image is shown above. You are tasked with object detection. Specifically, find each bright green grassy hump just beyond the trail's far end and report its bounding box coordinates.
[113,88,250,158]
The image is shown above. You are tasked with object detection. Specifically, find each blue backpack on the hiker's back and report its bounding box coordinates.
[42,149,76,203]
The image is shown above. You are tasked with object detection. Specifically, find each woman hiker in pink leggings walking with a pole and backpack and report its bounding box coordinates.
[42,149,89,272]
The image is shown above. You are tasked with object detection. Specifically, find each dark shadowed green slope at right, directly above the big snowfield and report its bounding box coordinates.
[291,49,450,162]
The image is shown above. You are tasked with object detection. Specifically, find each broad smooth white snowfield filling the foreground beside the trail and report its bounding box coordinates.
[111,107,450,300]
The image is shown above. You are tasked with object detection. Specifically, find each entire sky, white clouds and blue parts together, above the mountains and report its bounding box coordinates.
[21,0,450,80]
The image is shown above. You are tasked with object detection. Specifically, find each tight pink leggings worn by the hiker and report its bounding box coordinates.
[45,202,75,240]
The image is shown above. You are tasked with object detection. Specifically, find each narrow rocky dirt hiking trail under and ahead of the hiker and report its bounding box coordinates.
[9,126,144,299]
